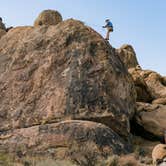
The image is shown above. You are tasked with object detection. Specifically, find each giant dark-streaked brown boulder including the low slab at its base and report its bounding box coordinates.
[0,12,136,163]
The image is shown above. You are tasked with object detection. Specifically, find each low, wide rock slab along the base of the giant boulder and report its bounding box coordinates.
[0,120,129,158]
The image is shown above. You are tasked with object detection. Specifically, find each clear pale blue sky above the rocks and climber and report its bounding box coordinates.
[0,0,166,76]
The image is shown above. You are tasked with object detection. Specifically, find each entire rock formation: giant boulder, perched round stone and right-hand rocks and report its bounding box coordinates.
[0,10,166,166]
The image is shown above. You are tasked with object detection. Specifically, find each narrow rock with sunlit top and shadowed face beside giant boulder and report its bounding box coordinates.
[128,68,153,102]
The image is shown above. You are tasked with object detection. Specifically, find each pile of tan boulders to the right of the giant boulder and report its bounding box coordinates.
[118,46,166,139]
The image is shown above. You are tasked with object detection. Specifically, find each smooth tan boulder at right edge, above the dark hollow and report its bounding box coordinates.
[135,102,166,137]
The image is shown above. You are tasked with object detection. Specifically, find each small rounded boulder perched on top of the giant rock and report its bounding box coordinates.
[34,10,62,26]
